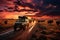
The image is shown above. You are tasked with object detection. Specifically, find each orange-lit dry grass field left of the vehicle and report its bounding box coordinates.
[0,19,17,27]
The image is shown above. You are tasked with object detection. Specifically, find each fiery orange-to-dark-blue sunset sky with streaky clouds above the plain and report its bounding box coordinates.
[0,0,60,19]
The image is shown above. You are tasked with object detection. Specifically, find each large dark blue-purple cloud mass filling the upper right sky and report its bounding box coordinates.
[33,0,60,16]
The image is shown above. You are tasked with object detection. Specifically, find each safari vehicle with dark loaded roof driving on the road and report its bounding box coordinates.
[14,16,28,31]
